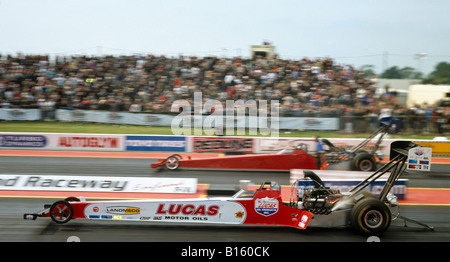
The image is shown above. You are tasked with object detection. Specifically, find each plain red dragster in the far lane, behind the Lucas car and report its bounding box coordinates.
[150,117,401,171]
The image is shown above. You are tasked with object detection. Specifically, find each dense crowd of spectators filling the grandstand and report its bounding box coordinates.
[0,55,450,132]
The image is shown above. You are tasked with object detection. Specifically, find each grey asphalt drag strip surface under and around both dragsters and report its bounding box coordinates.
[0,152,450,243]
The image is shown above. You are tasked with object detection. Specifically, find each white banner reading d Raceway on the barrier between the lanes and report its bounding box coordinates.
[0,174,197,194]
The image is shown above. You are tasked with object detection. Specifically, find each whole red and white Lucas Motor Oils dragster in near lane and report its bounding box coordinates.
[23,141,433,235]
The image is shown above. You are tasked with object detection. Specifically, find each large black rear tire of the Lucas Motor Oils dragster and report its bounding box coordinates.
[350,197,391,236]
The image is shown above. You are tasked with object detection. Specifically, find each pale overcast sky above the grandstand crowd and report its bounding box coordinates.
[0,0,450,73]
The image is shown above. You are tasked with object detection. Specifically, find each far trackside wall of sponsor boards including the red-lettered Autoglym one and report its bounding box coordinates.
[0,132,450,157]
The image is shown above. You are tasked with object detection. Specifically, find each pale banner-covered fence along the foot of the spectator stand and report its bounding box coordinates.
[0,108,450,134]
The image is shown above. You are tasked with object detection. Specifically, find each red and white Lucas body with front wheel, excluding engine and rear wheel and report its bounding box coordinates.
[24,182,313,229]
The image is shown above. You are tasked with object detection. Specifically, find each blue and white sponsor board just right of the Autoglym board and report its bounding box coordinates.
[125,136,187,152]
